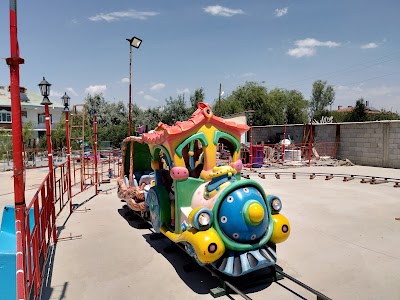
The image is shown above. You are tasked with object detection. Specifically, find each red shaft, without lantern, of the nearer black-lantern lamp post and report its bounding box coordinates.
[44,104,57,243]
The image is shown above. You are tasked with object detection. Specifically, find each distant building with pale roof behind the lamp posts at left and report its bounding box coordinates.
[0,86,64,139]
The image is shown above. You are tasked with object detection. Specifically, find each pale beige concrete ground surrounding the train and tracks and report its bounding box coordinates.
[0,166,400,299]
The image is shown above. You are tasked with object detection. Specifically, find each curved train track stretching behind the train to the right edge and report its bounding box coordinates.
[241,169,400,188]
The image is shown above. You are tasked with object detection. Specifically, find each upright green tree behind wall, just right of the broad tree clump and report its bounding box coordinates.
[310,80,335,120]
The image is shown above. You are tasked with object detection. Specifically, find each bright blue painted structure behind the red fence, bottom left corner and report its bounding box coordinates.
[0,205,35,299]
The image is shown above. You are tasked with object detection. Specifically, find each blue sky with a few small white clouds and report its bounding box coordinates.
[0,0,400,112]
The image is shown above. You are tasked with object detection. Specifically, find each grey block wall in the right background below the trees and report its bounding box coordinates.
[253,120,400,168]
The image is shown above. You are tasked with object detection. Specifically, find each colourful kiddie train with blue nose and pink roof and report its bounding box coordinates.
[118,103,290,276]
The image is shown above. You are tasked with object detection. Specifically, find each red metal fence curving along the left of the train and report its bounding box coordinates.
[16,151,121,299]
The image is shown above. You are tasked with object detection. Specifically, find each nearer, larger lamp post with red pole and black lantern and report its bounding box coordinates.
[38,77,57,243]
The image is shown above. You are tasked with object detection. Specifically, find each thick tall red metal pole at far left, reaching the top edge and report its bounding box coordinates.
[6,0,27,299]
